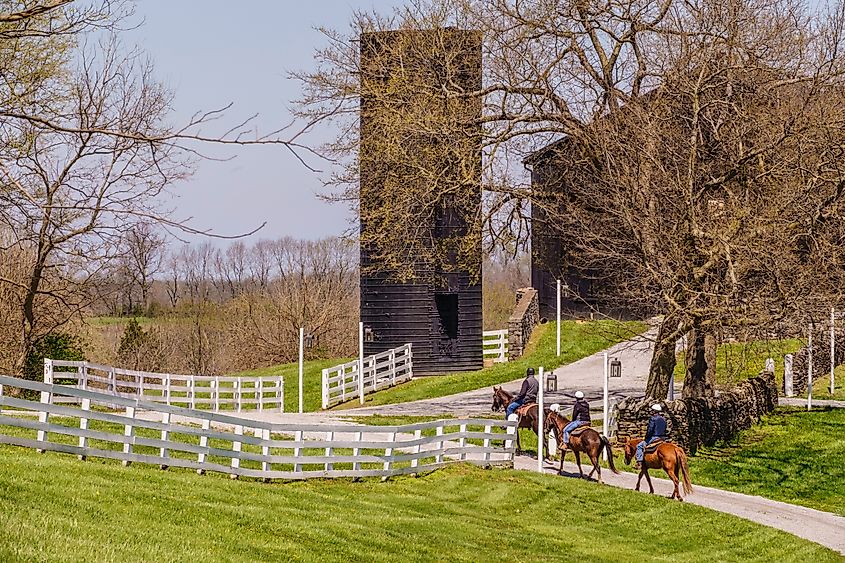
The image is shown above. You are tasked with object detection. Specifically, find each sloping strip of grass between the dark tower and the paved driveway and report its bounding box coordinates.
[336,321,647,409]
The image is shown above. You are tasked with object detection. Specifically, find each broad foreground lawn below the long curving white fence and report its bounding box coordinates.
[0,447,840,562]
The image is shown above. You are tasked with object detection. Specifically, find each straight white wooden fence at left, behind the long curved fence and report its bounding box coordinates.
[44,359,285,412]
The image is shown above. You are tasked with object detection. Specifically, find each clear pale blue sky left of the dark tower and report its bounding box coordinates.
[124,0,401,245]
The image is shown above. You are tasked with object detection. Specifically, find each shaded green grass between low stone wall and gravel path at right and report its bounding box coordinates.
[690,408,845,516]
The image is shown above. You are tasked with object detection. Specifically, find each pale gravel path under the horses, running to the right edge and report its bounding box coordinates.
[514,456,845,555]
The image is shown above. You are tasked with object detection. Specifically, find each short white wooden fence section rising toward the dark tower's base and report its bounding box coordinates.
[322,344,414,409]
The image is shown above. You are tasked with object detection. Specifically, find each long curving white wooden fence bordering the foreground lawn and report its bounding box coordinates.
[0,376,516,480]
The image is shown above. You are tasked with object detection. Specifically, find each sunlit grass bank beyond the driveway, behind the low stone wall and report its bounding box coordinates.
[675,338,845,401]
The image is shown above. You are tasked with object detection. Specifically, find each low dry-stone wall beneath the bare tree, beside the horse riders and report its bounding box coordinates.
[615,371,778,454]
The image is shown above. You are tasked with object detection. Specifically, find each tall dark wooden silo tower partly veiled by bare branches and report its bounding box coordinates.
[359,28,483,374]
